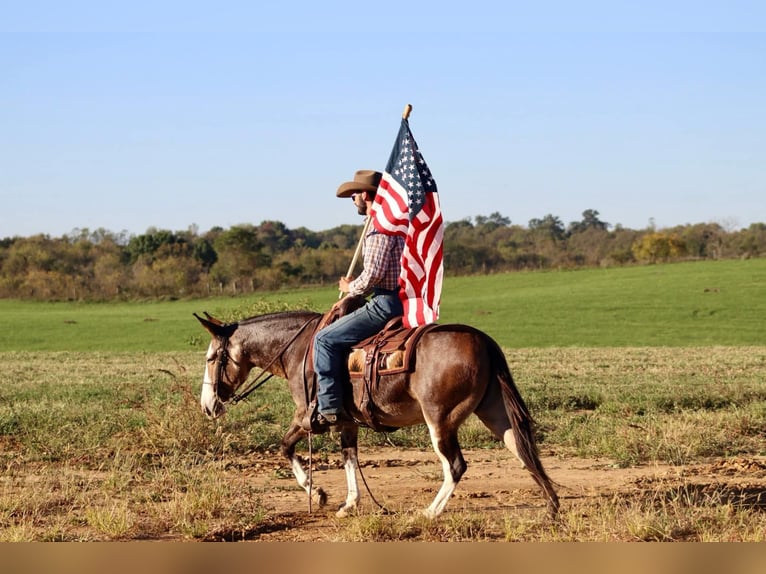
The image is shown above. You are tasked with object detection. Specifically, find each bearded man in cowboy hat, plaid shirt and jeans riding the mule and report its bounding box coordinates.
[312,170,404,432]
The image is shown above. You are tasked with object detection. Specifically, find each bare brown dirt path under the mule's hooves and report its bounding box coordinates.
[202,448,766,541]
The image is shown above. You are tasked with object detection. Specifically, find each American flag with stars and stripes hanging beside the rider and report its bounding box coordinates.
[372,119,444,327]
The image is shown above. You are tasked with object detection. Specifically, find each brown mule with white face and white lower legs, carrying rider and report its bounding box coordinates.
[195,311,559,518]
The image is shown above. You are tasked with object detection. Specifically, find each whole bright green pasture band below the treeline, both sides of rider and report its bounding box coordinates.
[0,259,766,352]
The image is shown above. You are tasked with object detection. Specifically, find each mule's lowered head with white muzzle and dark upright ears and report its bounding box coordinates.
[194,313,252,418]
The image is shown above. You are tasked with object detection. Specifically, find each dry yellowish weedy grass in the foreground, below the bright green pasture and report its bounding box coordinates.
[0,347,766,541]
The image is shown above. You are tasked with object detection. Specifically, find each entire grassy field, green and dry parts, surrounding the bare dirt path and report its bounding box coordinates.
[0,260,766,541]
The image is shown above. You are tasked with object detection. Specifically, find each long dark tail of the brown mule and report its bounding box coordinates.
[487,337,559,518]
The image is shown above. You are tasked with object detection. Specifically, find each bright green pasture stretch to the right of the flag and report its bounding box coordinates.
[442,259,766,347]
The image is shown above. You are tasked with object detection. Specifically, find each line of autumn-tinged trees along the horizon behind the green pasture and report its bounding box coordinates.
[0,209,766,300]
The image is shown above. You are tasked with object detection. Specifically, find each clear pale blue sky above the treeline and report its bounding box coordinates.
[0,0,766,238]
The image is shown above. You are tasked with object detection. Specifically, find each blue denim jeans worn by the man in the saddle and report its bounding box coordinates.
[314,292,404,414]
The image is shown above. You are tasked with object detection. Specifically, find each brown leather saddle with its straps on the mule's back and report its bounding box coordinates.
[304,296,438,431]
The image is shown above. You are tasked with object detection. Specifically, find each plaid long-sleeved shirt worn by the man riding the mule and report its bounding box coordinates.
[349,229,404,295]
